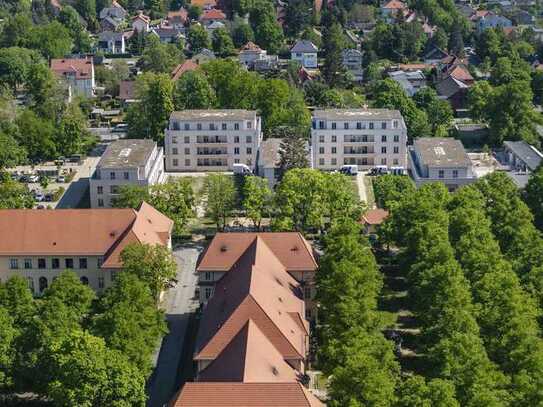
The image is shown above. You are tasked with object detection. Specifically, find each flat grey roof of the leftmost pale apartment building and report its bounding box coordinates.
[97,139,156,168]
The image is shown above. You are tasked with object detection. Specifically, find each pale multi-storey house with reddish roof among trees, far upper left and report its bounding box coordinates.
[51,58,95,98]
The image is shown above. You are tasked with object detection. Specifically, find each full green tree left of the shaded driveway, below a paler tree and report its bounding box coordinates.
[92,273,167,376]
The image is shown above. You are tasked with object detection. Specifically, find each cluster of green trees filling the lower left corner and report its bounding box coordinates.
[0,241,176,407]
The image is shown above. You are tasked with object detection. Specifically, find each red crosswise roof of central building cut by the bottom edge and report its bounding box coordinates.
[169,382,324,407]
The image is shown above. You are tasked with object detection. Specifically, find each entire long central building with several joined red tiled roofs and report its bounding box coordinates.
[169,233,324,407]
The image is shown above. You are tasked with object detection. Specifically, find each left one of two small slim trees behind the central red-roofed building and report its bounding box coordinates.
[204,174,236,230]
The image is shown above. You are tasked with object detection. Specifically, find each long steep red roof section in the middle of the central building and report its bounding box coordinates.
[195,237,308,360]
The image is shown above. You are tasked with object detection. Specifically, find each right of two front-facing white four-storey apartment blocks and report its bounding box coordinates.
[311,109,407,170]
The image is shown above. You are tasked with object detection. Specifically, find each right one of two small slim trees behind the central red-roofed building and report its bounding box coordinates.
[243,177,272,230]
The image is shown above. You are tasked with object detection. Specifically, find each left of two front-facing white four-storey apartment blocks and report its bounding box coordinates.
[164,110,262,171]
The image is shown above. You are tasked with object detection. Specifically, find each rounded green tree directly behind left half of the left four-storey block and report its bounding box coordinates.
[173,71,216,110]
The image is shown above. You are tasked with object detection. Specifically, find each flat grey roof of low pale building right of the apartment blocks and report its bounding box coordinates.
[414,137,471,167]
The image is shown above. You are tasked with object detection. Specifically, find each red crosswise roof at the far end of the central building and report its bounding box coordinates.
[197,232,317,272]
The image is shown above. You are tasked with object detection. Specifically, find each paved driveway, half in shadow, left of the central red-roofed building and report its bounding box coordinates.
[147,244,202,407]
